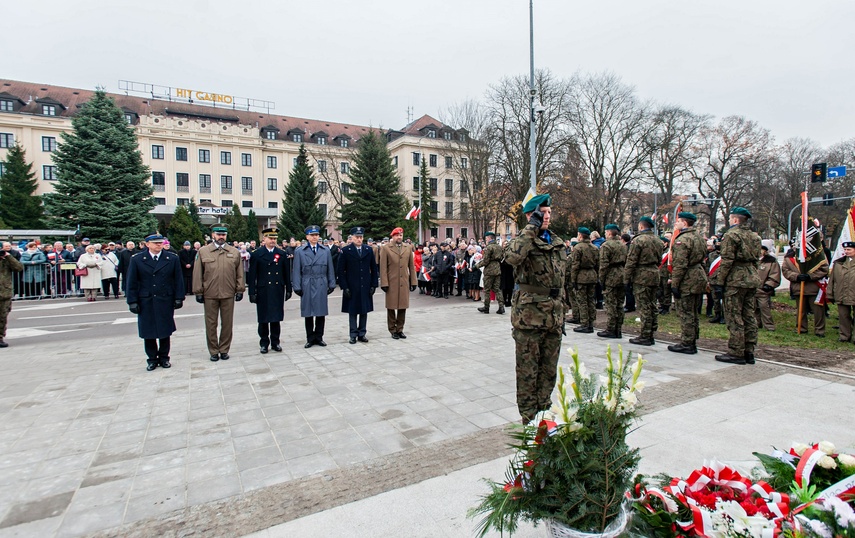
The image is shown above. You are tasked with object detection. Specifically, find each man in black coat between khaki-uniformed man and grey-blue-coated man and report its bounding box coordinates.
[246,228,291,353]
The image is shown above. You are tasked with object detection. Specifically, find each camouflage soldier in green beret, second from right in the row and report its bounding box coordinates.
[668,212,707,355]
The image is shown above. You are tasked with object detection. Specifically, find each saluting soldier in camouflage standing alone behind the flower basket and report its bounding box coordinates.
[505,194,567,424]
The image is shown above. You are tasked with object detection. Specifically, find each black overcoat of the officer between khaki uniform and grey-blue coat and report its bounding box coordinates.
[246,246,291,323]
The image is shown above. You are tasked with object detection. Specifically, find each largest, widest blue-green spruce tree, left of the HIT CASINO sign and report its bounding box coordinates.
[45,89,157,243]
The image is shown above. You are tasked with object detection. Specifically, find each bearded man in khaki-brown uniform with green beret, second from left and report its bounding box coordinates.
[193,225,246,362]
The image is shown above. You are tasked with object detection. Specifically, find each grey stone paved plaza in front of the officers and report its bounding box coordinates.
[0,292,855,538]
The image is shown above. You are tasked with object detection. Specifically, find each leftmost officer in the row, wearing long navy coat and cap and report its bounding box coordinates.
[126,234,184,372]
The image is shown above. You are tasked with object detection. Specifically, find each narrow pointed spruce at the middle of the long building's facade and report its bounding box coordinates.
[279,144,326,241]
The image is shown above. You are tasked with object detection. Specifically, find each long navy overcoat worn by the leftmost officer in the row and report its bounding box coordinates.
[125,249,184,338]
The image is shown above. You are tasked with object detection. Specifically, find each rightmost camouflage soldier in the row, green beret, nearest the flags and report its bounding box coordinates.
[714,207,760,364]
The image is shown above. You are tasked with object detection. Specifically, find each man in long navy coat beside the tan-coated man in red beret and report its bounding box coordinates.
[336,226,379,344]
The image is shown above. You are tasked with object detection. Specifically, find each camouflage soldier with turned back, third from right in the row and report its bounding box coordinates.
[623,217,663,346]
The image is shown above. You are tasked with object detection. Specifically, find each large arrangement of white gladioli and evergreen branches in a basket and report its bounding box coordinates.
[469,346,644,536]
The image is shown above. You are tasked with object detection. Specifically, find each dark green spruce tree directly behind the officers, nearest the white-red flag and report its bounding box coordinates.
[341,131,409,237]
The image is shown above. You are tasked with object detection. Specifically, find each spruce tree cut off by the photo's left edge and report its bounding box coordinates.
[0,144,45,226]
